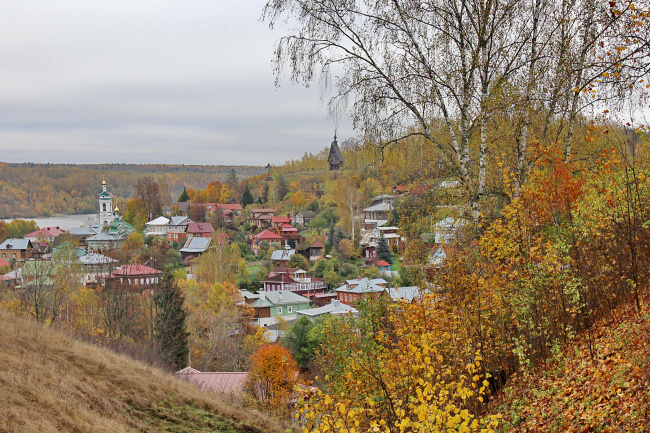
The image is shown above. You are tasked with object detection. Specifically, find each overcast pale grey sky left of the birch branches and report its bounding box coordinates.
[0,0,353,165]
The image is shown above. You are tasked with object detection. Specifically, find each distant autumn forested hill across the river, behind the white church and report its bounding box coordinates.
[0,162,264,218]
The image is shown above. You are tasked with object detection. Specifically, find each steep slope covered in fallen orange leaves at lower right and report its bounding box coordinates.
[490,291,650,433]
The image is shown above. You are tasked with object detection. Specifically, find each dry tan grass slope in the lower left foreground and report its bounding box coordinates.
[0,311,284,433]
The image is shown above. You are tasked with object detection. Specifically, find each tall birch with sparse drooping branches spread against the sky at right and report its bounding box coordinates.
[263,0,648,209]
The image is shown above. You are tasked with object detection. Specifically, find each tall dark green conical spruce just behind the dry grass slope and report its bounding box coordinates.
[153,271,189,370]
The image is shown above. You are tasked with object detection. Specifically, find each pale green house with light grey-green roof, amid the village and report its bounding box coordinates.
[242,290,309,326]
